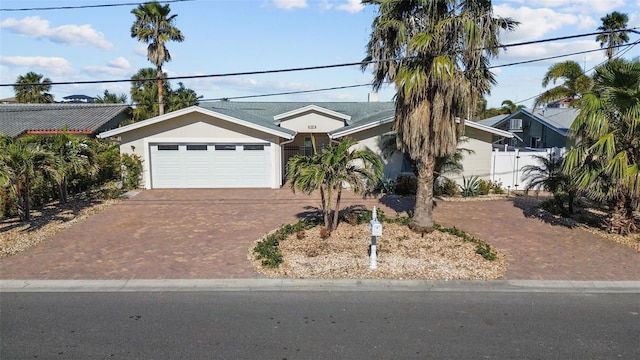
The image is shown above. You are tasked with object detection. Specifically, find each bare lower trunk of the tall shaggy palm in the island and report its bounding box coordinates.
[409,154,435,233]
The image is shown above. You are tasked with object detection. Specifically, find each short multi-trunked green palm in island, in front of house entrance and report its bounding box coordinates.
[287,138,382,234]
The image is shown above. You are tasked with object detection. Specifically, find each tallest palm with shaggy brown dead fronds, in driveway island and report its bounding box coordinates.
[363,0,517,232]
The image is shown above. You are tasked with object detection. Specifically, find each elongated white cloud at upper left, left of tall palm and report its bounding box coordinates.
[0,16,113,50]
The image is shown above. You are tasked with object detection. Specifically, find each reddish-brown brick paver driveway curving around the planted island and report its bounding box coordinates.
[0,189,640,280]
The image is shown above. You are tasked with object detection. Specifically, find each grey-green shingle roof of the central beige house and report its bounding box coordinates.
[199,101,395,125]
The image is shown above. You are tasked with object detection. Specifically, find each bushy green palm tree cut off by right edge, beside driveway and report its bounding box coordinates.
[565,59,640,233]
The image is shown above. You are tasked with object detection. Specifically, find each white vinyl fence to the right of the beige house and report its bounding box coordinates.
[490,147,565,190]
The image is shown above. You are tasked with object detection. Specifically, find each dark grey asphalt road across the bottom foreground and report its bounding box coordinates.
[0,291,640,359]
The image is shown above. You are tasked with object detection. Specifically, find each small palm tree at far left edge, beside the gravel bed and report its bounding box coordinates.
[0,138,56,222]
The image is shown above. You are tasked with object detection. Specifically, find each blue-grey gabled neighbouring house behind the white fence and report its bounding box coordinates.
[478,107,578,149]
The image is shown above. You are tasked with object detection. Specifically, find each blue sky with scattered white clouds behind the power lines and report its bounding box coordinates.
[0,0,640,107]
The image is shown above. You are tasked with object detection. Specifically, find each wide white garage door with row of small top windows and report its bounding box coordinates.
[150,143,272,188]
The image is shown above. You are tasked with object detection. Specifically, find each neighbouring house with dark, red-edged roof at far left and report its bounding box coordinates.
[0,103,131,137]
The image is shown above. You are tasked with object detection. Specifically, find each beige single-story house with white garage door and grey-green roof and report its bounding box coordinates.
[98,101,513,189]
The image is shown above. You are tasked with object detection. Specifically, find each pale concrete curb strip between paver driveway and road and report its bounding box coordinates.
[0,279,640,294]
